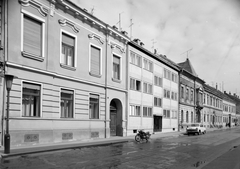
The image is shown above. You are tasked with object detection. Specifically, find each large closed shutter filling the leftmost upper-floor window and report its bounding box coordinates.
[23,15,42,56]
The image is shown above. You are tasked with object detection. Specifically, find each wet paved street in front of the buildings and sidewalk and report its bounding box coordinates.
[0,128,240,169]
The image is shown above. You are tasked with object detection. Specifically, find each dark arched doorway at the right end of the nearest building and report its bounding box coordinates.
[110,99,123,136]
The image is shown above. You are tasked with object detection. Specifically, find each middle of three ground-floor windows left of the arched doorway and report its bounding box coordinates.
[61,89,73,118]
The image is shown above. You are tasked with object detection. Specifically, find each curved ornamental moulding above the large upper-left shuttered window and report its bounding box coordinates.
[18,0,48,16]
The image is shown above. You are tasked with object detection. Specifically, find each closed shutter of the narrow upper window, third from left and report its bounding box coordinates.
[91,46,100,75]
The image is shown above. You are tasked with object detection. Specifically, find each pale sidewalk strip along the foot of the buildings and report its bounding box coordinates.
[0,131,185,158]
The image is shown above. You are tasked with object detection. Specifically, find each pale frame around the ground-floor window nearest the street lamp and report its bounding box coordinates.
[19,80,43,118]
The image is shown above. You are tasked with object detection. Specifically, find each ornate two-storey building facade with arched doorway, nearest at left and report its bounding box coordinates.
[1,0,129,146]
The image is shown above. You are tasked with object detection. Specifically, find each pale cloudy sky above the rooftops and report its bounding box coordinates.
[72,0,240,96]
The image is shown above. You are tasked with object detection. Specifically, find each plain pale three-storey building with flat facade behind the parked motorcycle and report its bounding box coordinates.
[127,39,179,135]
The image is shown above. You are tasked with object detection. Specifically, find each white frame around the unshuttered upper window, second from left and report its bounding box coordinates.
[59,29,77,70]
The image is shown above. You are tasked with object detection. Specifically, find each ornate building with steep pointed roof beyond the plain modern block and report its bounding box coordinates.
[178,58,205,128]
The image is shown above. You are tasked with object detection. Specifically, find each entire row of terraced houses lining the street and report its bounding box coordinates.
[0,0,240,146]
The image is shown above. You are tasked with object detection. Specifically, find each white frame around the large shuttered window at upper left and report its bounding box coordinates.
[21,9,46,62]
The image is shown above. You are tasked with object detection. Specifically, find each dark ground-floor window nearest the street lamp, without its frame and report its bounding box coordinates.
[22,82,41,117]
